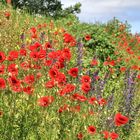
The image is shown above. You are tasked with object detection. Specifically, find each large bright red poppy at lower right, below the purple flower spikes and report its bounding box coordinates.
[114,113,129,126]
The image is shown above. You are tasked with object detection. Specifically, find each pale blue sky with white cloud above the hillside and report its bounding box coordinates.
[61,0,140,33]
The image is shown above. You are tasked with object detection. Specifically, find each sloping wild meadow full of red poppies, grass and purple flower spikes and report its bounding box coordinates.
[0,3,140,140]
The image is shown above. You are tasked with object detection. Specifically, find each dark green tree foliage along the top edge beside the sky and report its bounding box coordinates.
[9,0,81,18]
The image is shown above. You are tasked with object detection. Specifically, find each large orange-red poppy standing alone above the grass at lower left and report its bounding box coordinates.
[38,96,54,107]
